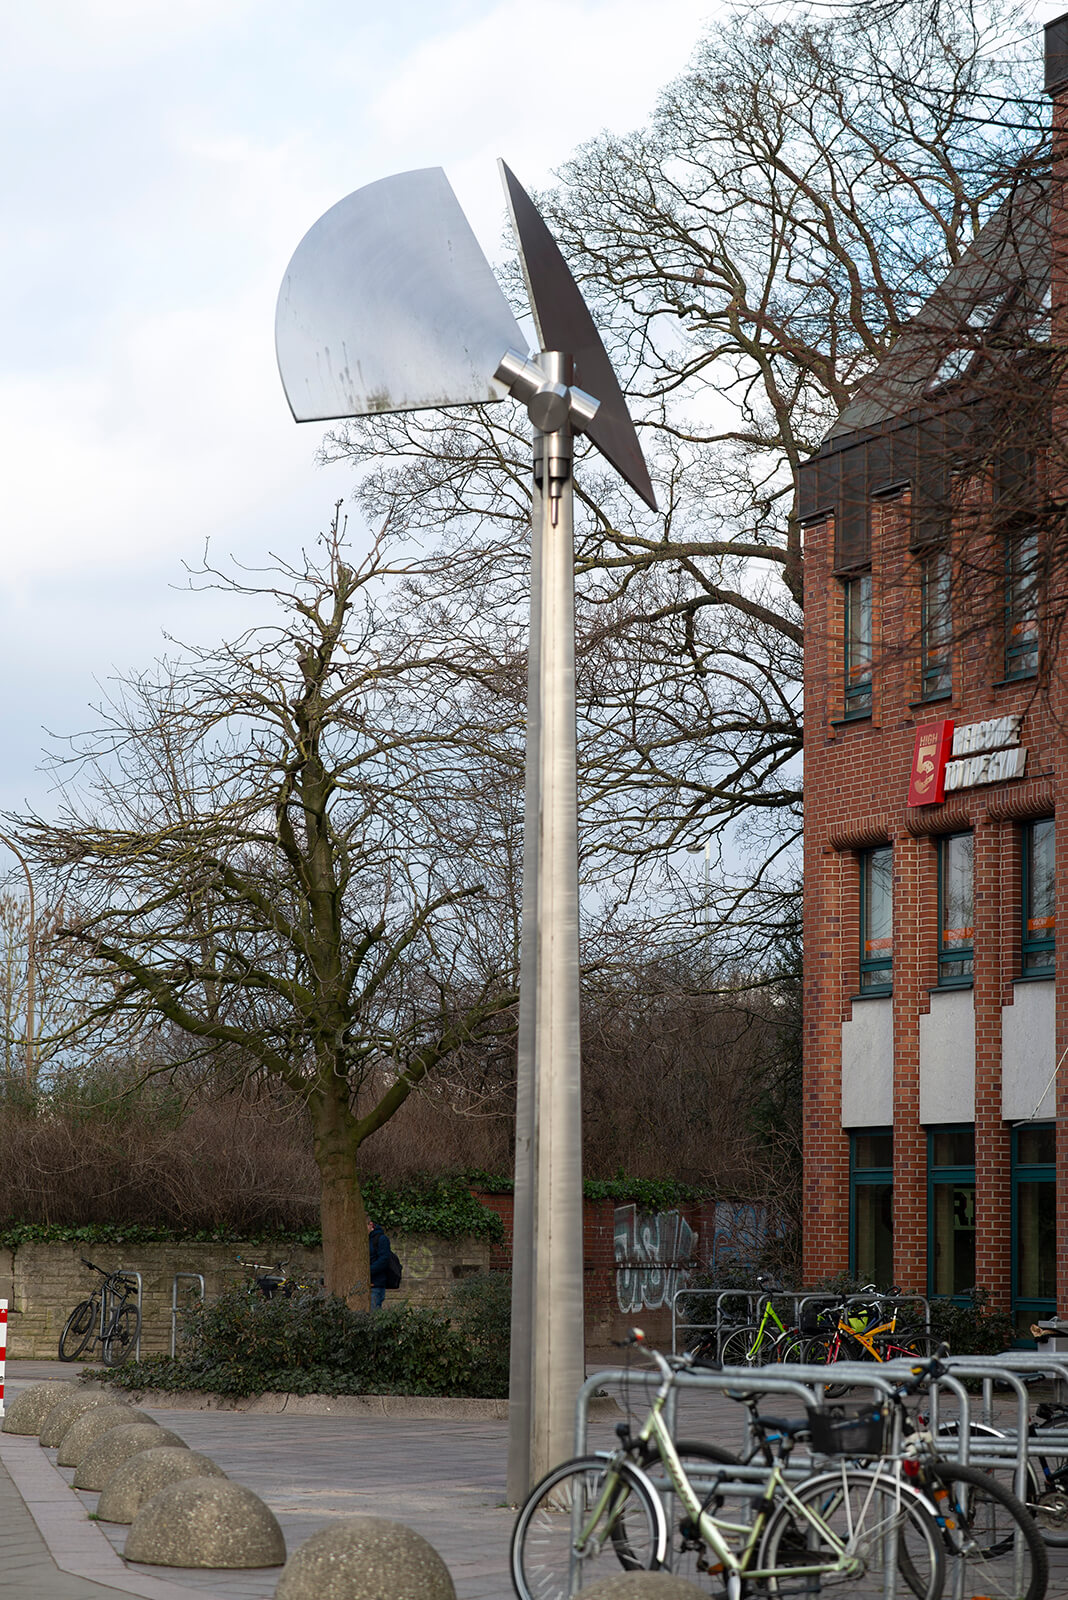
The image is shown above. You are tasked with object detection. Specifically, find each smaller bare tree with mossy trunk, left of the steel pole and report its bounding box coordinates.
[16,523,516,1304]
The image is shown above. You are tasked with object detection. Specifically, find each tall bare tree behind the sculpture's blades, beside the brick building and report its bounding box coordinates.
[323,0,1046,934]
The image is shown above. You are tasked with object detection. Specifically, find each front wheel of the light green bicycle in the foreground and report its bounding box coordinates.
[512,1456,667,1600]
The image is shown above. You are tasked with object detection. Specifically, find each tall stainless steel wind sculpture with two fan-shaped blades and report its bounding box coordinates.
[275,162,656,1501]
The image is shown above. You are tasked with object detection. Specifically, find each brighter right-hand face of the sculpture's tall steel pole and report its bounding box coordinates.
[524,352,585,1480]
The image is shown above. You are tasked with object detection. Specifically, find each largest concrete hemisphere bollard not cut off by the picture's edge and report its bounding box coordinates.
[123,1478,286,1568]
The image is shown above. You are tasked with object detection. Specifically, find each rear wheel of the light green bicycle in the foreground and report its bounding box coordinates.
[756,1467,940,1600]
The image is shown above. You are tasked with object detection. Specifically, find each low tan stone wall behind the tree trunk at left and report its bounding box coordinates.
[0,1234,492,1360]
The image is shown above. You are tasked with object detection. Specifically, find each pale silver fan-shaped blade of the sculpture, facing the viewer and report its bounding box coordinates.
[275,166,526,422]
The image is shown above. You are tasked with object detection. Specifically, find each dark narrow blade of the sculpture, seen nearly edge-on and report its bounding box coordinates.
[499,162,657,510]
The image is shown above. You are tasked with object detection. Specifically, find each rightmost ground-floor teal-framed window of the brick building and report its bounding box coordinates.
[1012,1122,1057,1334]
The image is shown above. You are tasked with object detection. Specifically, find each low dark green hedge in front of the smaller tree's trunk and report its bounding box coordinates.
[93,1285,507,1397]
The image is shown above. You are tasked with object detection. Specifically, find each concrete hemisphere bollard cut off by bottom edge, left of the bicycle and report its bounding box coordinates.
[275,1517,456,1600]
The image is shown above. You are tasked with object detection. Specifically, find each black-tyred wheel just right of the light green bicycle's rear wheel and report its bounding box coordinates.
[929,1461,1049,1600]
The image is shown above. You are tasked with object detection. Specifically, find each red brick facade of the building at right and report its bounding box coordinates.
[801,19,1068,1314]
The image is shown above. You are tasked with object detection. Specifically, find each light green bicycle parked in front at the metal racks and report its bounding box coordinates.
[510,1331,945,1600]
